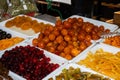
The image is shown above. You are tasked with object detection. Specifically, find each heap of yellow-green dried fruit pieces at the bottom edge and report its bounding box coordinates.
[49,66,110,80]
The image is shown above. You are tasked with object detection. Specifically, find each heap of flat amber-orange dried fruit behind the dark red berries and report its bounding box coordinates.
[5,16,51,33]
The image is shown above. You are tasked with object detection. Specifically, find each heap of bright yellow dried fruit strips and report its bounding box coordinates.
[78,50,120,80]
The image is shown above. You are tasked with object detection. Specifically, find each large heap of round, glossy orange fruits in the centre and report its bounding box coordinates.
[32,18,110,60]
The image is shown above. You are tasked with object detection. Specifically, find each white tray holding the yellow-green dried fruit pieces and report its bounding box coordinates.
[42,63,112,80]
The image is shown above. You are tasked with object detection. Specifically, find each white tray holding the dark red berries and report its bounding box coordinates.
[0,43,68,80]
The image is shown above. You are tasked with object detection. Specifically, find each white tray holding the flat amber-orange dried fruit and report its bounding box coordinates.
[0,15,54,37]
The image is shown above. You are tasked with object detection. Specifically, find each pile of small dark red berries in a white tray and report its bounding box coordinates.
[0,45,59,80]
